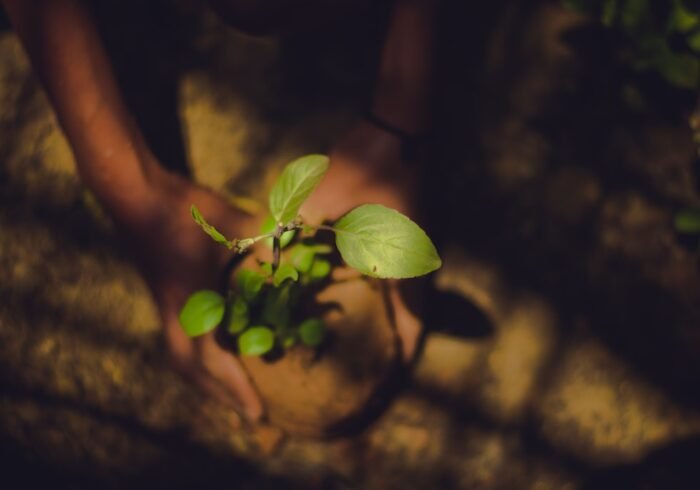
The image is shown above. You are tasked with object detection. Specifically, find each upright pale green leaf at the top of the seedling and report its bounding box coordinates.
[269,155,328,225]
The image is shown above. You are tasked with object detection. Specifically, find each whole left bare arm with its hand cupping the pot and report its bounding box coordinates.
[0,0,263,419]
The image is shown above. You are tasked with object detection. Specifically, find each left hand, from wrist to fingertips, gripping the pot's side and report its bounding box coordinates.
[121,171,264,422]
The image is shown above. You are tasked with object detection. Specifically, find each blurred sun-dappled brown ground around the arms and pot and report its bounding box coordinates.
[0,0,700,490]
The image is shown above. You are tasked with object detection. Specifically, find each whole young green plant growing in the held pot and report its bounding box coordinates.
[180,155,441,355]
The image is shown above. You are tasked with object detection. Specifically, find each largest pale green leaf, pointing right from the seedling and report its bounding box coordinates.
[333,204,442,279]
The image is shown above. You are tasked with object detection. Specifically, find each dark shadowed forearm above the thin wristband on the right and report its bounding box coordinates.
[372,0,439,133]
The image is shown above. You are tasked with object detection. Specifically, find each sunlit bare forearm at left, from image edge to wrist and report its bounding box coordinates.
[2,0,159,226]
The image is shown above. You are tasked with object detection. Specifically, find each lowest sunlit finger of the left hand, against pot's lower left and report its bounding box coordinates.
[195,334,264,422]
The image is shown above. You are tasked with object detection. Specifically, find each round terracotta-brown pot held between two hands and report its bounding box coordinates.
[241,279,401,437]
